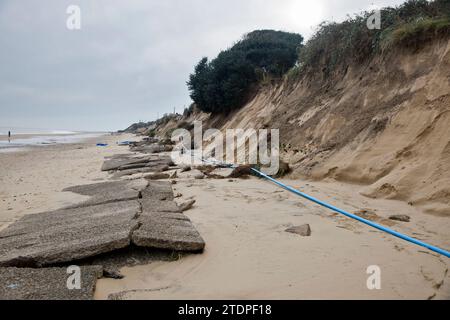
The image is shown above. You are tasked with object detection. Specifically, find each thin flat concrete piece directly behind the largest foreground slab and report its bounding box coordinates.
[63,179,148,208]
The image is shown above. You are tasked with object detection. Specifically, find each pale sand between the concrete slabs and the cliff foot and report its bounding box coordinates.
[96,178,450,299]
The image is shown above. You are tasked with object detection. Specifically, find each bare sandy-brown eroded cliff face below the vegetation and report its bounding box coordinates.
[156,39,450,216]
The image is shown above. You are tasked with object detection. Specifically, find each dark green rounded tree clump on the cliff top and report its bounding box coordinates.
[187,30,303,113]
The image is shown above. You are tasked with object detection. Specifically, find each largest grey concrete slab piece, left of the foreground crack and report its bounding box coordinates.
[0,201,141,267]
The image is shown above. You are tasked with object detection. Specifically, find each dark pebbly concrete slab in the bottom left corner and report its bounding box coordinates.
[0,266,103,300]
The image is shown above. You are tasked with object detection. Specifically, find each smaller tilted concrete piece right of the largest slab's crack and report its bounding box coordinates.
[132,212,205,252]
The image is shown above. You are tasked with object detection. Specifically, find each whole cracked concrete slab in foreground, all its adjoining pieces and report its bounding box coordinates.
[0,179,205,267]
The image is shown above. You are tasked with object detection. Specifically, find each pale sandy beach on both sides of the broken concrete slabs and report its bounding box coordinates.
[0,135,450,299]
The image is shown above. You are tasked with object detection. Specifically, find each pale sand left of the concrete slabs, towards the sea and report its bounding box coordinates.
[0,135,135,229]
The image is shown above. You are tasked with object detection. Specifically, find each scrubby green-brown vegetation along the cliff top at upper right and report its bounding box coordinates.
[294,0,450,79]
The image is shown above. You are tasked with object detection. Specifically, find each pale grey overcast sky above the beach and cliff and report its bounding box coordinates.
[0,0,403,131]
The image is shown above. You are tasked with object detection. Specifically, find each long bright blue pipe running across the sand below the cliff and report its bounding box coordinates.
[252,168,450,258]
